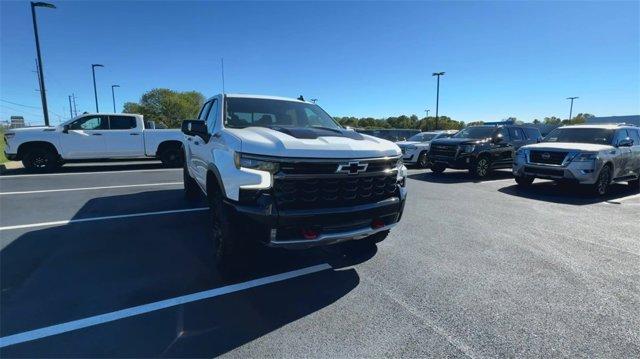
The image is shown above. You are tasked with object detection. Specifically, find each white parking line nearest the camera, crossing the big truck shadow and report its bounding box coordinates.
[0,263,332,348]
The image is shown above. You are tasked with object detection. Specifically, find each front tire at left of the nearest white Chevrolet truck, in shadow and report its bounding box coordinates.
[208,184,247,275]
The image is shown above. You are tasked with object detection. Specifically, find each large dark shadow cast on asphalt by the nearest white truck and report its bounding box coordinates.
[0,191,370,357]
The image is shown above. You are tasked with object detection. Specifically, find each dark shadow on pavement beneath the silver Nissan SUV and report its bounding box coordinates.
[498,181,639,206]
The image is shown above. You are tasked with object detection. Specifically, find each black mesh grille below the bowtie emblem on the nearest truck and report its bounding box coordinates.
[273,172,398,209]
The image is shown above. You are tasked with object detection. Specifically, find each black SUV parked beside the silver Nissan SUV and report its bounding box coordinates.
[430,125,542,178]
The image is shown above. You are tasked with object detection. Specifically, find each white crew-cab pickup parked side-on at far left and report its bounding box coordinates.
[5,113,184,171]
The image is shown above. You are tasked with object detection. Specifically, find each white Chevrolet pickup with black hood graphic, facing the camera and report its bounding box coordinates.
[182,94,406,268]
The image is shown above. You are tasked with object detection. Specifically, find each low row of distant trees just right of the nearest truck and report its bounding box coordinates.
[334,115,464,131]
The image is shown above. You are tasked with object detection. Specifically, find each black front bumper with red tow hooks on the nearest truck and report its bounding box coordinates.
[228,186,406,249]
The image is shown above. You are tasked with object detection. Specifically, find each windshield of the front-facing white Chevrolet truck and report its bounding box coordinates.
[224,97,342,130]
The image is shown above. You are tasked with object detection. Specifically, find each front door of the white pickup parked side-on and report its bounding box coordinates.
[60,115,109,159]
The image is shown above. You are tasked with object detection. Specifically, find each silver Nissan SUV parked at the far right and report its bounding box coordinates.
[513,124,640,195]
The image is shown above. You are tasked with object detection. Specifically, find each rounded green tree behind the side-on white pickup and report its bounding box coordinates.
[123,88,205,128]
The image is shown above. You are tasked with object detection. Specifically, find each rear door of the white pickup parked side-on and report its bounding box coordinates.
[103,115,144,157]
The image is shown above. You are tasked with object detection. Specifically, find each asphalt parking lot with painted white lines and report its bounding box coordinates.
[0,163,640,357]
